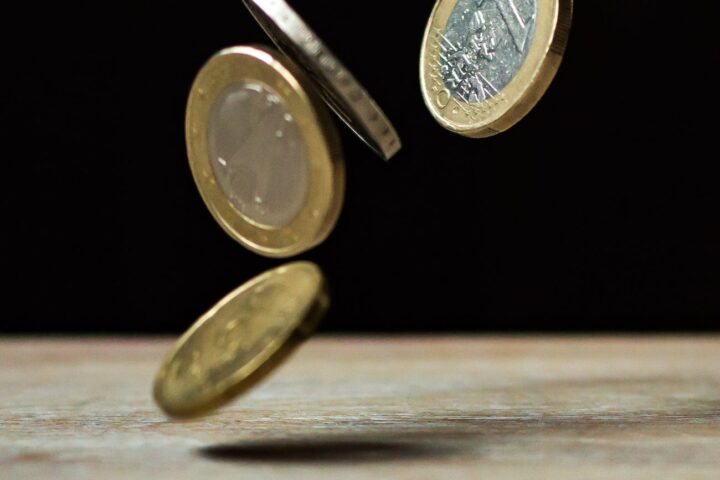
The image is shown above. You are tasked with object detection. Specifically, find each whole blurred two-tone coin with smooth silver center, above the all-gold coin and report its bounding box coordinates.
[185,46,345,257]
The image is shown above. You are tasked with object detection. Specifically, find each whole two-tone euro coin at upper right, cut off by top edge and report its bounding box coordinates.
[420,0,572,138]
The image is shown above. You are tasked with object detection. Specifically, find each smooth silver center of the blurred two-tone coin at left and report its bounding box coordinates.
[208,82,309,228]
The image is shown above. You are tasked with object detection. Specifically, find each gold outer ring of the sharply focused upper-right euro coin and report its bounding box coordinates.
[420,0,573,138]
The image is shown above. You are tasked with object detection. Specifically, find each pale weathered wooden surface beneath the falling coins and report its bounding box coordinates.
[0,337,720,480]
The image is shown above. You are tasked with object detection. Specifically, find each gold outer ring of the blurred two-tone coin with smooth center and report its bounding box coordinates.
[185,46,345,258]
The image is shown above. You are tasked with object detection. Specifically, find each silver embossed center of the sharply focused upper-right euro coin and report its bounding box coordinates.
[440,0,537,103]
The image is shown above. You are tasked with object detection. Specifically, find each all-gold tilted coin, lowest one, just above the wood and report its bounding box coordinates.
[154,262,329,417]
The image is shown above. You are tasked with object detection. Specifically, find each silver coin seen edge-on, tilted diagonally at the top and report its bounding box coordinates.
[243,0,402,160]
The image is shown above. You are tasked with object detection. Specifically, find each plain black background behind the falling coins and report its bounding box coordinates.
[0,0,720,333]
